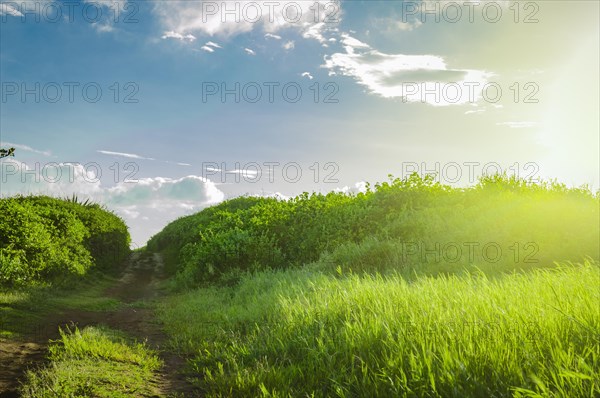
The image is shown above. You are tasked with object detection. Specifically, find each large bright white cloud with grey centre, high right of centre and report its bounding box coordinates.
[322,34,490,106]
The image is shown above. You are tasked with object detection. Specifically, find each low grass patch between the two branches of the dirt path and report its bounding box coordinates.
[21,327,162,398]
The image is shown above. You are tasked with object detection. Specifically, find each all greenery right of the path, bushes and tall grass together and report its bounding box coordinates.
[148,175,600,398]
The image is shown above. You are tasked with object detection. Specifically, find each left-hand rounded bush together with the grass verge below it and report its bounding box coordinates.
[0,196,130,338]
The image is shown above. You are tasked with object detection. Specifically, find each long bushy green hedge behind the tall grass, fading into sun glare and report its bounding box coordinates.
[148,174,600,286]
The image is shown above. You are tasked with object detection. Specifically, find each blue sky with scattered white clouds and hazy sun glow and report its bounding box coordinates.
[0,0,600,246]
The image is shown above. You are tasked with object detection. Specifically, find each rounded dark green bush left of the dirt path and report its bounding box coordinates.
[0,196,130,286]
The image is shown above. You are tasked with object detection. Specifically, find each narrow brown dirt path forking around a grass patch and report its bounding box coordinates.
[0,253,200,398]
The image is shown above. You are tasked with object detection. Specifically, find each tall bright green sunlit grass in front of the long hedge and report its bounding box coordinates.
[160,261,600,398]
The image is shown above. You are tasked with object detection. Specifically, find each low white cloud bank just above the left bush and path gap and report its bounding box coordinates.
[0,159,225,246]
